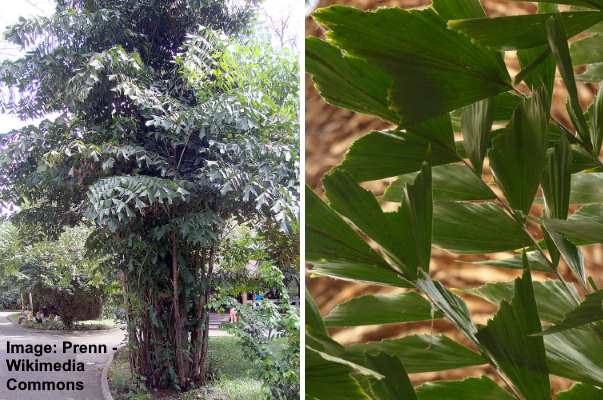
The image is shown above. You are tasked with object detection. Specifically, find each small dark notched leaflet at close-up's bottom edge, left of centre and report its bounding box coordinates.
[366,353,417,400]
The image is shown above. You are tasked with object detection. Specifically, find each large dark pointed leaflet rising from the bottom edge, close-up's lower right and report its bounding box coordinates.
[477,259,551,400]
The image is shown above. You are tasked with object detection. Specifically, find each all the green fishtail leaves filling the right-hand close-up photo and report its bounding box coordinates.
[305,0,603,400]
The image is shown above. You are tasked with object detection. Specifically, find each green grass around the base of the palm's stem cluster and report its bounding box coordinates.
[109,336,263,400]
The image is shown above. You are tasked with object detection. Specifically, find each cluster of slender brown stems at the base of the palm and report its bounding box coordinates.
[122,238,215,390]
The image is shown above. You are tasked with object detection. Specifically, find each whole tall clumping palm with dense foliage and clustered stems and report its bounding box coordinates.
[0,0,299,390]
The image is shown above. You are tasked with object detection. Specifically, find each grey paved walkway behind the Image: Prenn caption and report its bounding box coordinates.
[0,312,124,400]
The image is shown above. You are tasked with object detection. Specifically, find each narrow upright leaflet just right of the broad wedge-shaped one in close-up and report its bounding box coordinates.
[542,136,572,219]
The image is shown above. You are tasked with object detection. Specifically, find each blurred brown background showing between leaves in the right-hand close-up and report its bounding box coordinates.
[305,0,603,389]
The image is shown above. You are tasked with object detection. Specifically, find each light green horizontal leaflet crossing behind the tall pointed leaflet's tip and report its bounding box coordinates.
[464,280,578,323]
